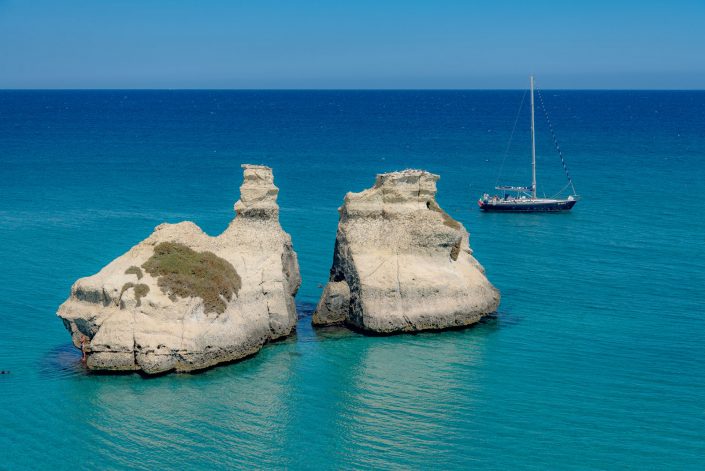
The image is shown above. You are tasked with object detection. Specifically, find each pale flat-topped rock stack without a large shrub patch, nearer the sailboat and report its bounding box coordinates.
[313,170,499,334]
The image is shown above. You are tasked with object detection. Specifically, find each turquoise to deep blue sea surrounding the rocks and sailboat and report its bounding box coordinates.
[0,91,705,470]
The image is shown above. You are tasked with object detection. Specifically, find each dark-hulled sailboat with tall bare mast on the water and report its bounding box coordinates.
[477,75,578,213]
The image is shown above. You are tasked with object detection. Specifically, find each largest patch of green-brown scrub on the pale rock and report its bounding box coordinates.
[142,242,241,314]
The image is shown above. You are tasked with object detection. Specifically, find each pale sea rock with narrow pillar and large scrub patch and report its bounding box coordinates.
[58,165,301,374]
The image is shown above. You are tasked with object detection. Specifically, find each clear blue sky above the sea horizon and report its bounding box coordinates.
[0,0,705,89]
